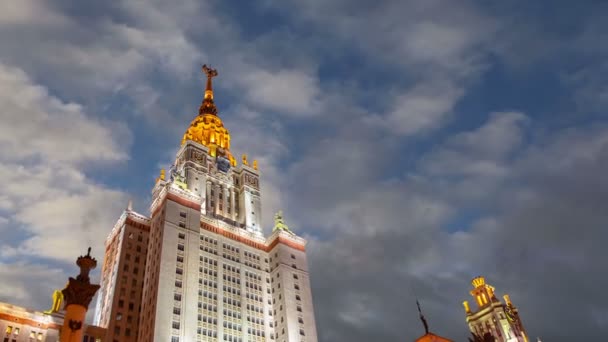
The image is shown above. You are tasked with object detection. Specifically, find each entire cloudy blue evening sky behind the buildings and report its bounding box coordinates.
[0,0,608,341]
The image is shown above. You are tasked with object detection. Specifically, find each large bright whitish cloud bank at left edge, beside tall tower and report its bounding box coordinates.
[0,64,130,261]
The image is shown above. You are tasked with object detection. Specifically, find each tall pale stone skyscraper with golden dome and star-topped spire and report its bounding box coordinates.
[97,66,317,342]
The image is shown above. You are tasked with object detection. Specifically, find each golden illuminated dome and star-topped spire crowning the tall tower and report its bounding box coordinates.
[182,65,236,166]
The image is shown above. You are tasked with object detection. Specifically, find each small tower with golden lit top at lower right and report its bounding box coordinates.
[462,277,528,342]
